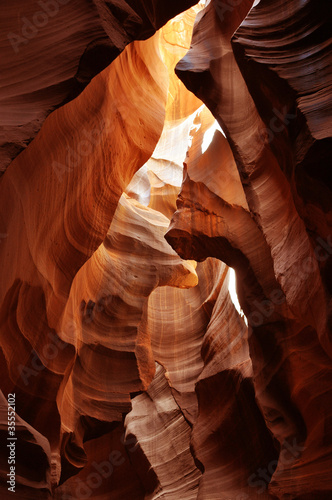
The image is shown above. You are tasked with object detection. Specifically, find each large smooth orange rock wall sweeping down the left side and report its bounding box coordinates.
[0,29,171,498]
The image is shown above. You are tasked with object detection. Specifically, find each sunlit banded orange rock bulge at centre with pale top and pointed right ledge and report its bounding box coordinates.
[58,191,197,476]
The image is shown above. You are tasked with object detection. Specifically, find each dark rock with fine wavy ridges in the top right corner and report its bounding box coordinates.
[233,0,332,140]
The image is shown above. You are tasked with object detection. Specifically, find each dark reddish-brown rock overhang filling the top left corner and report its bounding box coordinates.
[0,0,195,171]
